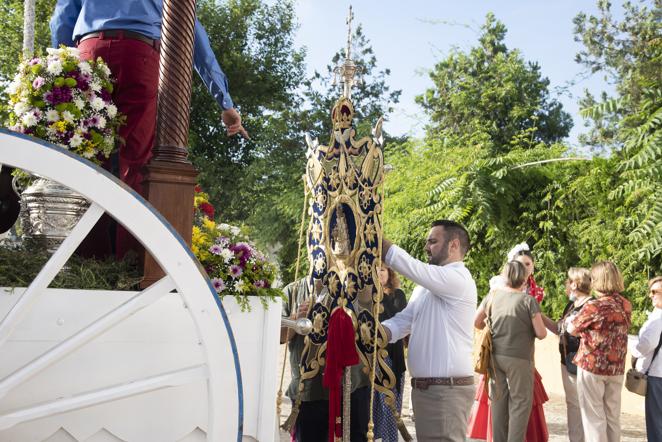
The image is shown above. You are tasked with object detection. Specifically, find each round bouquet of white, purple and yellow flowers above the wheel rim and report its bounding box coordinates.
[7,46,124,163]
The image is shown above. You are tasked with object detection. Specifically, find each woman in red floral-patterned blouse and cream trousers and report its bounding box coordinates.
[567,261,632,442]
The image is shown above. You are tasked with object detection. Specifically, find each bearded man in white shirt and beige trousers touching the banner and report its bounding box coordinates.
[382,220,478,442]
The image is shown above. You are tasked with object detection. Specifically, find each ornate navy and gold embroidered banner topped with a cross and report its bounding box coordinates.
[286,7,411,440]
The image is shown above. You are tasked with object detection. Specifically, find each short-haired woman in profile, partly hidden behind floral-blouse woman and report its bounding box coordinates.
[542,267,591,442]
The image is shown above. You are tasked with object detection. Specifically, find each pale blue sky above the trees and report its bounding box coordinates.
[296,0,621,145]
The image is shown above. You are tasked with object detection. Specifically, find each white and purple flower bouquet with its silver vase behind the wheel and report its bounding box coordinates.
[6,46,125,250]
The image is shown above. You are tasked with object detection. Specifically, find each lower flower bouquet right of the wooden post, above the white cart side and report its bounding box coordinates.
[191,186,281,311]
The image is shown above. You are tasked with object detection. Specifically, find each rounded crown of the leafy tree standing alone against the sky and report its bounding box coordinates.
[416,13,572,154]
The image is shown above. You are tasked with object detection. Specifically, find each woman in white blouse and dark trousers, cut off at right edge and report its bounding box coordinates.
[631,276,662,442]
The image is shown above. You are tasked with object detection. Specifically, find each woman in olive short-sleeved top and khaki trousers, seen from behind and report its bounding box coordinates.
[474,261,547,442]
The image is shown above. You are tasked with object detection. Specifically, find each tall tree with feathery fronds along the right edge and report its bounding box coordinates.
[575,0,662,278]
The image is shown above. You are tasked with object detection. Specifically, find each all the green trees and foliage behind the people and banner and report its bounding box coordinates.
[0,0,662,329]
